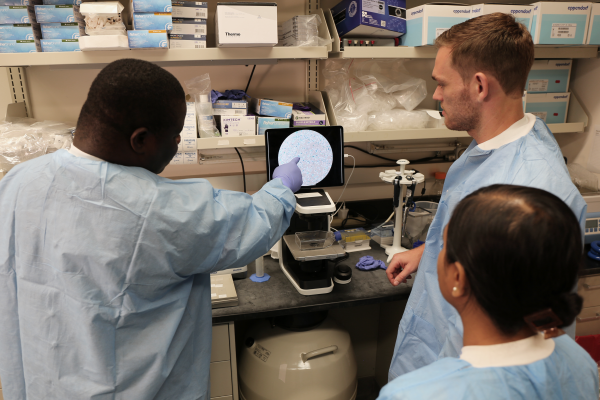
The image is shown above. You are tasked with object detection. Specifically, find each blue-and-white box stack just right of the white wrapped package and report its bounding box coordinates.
[127,0,173,49]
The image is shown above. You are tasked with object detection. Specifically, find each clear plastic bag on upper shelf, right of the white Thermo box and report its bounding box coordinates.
[277,14,331,47]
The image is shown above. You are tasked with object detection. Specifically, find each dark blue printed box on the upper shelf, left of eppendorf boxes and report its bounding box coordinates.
[331,0,407,38]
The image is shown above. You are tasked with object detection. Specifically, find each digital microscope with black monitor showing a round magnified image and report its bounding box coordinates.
[265,126,345,295]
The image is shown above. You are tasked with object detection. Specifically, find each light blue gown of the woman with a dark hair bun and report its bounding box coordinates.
[378,335,598,400]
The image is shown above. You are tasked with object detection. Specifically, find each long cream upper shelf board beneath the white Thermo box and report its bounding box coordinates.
[0,46,327,67]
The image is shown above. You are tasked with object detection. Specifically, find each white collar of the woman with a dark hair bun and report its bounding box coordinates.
[460,333,555,368]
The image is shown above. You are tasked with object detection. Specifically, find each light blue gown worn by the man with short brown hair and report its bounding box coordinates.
[388,118,587,381]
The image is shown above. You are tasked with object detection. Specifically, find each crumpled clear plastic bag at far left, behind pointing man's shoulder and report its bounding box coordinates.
[0,118,74,173]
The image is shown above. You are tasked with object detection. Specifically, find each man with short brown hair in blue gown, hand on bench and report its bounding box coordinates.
[387,13,586,380]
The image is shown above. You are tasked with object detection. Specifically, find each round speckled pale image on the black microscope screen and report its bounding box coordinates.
[278,129,333,186]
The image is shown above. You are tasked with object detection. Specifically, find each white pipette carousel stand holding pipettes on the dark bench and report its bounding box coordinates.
[379,160,425,262]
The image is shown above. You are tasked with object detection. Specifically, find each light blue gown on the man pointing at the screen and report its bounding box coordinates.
[0,150,295,400]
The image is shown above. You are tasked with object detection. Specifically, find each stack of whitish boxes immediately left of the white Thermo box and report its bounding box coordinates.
[169,1,208,49]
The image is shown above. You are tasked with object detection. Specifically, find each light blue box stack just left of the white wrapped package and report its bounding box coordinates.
[35,0,83,52]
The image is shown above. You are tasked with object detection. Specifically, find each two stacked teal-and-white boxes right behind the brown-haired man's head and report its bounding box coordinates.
[525,60,573,124]
